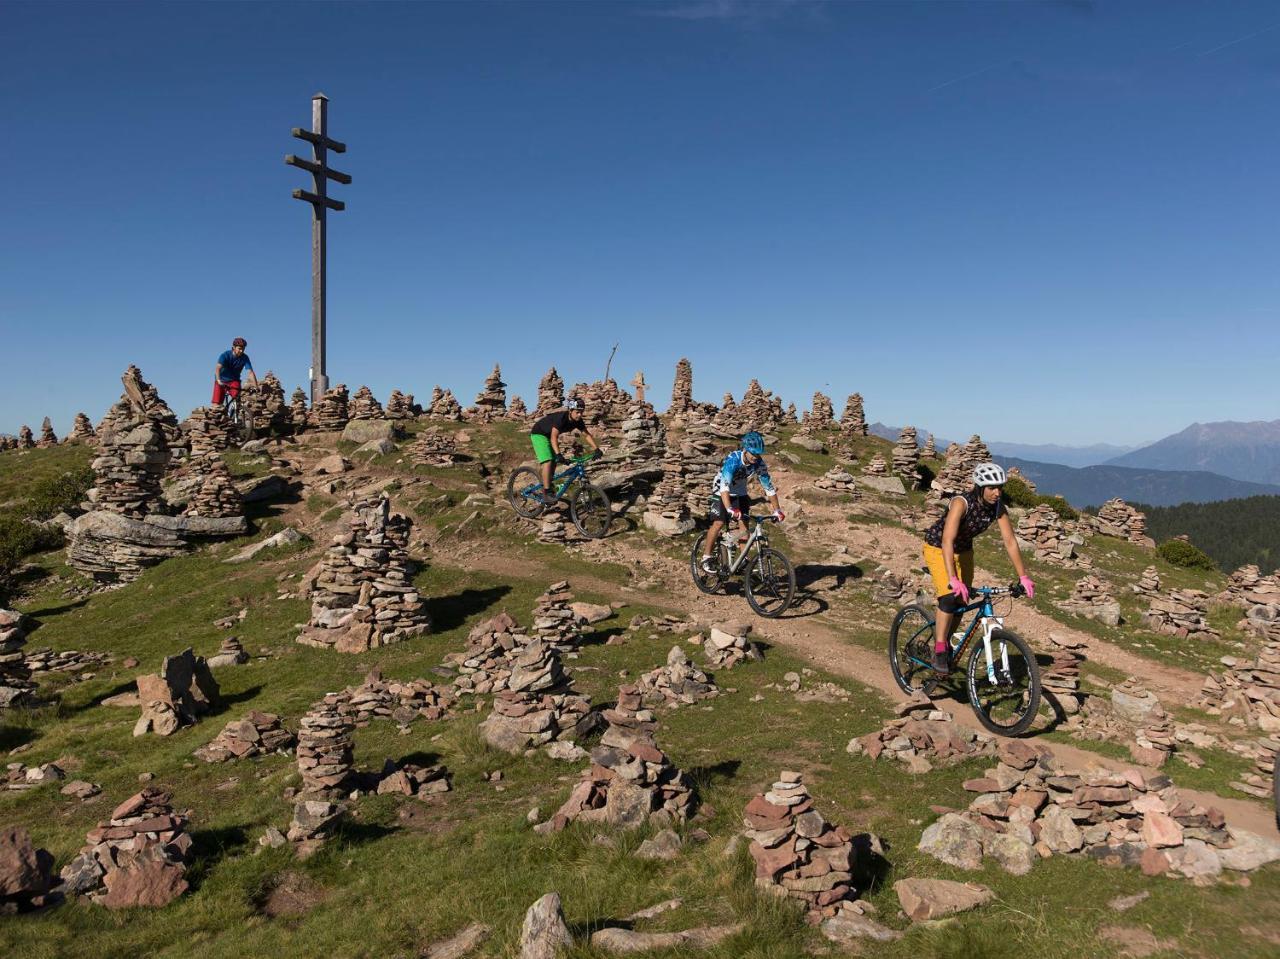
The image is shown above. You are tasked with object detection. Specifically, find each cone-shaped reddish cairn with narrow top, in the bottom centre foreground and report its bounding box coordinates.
[535,685,694,832]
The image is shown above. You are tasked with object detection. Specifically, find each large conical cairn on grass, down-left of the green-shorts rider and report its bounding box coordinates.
[298,496,431,653]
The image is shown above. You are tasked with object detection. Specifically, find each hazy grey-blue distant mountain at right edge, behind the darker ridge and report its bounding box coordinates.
[1106,420,1280,483]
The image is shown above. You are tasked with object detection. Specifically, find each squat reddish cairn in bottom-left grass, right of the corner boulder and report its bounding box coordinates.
[61,789,192,909]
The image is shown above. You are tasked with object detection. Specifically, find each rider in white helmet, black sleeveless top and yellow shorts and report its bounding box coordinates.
[924,462,1036,676]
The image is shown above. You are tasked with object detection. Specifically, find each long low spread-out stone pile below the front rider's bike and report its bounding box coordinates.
[919,739,1280,885]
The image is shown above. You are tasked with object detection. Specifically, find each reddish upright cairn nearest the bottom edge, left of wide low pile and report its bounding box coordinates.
[742,770,858,922]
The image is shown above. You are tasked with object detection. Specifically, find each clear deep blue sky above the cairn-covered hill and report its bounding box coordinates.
[0,0,1280,443]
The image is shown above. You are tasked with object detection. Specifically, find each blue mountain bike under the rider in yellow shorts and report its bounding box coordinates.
[888,583,1041,736]
